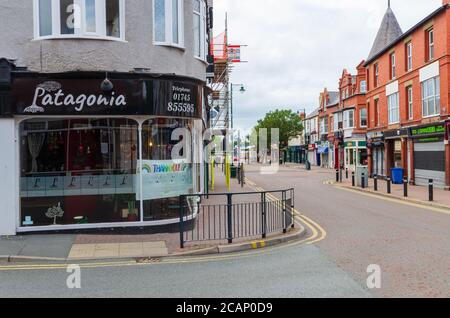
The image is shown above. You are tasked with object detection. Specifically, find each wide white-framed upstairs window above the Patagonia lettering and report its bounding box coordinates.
[34,0,125,40]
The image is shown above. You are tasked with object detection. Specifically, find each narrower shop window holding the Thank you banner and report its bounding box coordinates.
[139,119,199,221]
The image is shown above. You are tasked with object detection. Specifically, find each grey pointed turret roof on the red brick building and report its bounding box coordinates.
[367,7,403,60]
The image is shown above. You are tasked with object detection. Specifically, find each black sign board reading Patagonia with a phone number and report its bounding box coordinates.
[4,74,203,119]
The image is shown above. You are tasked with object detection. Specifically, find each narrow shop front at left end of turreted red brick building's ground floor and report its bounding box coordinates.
[367,132,386,177]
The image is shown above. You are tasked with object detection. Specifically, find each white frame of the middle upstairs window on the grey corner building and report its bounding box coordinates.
[152,0,185,49]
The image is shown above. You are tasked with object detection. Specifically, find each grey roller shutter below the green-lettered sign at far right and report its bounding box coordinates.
[414,141,445,187]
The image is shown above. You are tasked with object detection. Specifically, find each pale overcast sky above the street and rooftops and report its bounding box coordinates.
[214,0,442,131]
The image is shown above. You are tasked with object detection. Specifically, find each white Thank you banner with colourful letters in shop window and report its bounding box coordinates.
[135,160,193,201]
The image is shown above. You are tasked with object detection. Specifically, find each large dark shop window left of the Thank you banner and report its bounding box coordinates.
[20,119,140,226]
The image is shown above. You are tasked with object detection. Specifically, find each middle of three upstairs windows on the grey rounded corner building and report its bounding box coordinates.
[153,0,184,47]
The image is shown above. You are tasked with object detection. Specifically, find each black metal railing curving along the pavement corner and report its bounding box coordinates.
[179,189,295,248]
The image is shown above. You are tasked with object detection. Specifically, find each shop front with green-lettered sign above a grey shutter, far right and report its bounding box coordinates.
[409,122,448,188]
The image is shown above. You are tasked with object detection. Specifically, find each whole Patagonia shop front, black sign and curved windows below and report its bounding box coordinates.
[0,72,206,234]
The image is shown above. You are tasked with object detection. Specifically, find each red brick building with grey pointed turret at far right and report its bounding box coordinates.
[364,0,450,188]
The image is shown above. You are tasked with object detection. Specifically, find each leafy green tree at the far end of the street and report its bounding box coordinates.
[255,109,303,150]
